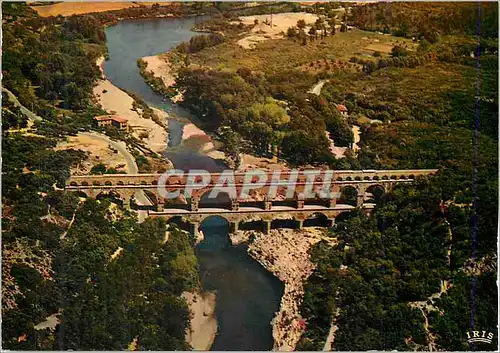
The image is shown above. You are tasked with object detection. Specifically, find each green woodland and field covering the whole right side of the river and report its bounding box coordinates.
[171,3,498,350]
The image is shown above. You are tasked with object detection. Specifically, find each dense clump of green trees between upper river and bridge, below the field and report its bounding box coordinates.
[176,68,353,166]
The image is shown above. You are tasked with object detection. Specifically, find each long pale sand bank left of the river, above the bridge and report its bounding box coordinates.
[94,57,168,153]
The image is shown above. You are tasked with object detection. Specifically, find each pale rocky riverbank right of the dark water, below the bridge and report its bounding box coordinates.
[229,227,336,351]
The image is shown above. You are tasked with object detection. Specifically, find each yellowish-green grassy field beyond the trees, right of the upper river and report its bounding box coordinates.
[191,29,415,72]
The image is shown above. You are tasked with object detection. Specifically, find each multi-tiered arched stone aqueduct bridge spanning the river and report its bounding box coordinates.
[65,169,437,235]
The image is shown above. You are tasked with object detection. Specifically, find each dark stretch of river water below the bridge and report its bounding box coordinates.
[196,216,284,350]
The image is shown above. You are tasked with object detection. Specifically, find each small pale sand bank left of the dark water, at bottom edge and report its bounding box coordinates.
[182,292,217,351]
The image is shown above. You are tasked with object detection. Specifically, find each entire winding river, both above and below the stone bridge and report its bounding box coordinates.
[104,18,283,350]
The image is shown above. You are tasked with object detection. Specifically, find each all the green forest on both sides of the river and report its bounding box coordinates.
[2,2,498,350]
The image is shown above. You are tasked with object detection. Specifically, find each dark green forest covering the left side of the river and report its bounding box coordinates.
[2,2,198,350]
